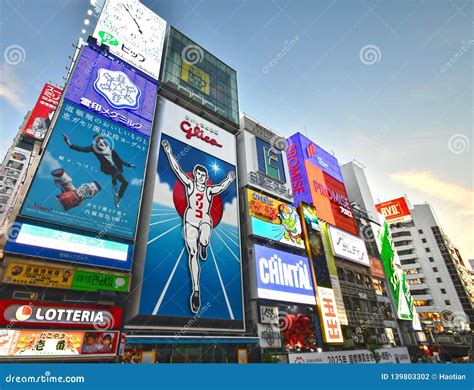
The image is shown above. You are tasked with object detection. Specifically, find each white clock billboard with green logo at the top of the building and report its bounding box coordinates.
[92,0,166,80]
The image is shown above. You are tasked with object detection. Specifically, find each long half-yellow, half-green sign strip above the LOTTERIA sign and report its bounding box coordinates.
[2,260,130,292]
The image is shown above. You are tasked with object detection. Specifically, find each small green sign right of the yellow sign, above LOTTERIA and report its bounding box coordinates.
[71,270,130,292]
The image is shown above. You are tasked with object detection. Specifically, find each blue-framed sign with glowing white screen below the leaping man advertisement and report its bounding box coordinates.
[4,222,134,271]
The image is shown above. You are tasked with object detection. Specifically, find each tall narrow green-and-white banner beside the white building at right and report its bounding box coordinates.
[378,221,415,320]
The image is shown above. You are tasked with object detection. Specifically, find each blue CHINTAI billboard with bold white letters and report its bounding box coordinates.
[254,245,316,305]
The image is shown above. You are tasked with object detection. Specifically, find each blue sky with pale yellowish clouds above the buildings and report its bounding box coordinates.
[0,0,474,260]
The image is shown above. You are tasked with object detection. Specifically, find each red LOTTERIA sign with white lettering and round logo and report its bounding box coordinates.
[0,300,122,330]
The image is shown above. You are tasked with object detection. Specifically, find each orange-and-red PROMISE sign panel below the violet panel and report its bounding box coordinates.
[304,161,358,236]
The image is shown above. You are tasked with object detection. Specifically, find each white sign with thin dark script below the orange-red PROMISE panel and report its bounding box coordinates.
[329,226,370,267]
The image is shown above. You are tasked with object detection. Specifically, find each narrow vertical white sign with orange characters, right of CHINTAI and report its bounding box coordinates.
[317,286,344,344]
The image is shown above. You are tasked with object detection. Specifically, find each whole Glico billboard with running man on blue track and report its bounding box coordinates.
[139,98,243,326]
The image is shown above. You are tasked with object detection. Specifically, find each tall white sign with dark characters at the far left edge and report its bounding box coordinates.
[0,147,31,235]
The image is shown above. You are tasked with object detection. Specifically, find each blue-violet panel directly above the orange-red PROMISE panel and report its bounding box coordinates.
[288,133,344,183]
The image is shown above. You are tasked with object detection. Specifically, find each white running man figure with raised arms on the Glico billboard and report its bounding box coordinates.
[161,140,235,313]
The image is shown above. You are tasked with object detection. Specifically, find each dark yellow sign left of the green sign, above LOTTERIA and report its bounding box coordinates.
[2,261,74,289]
